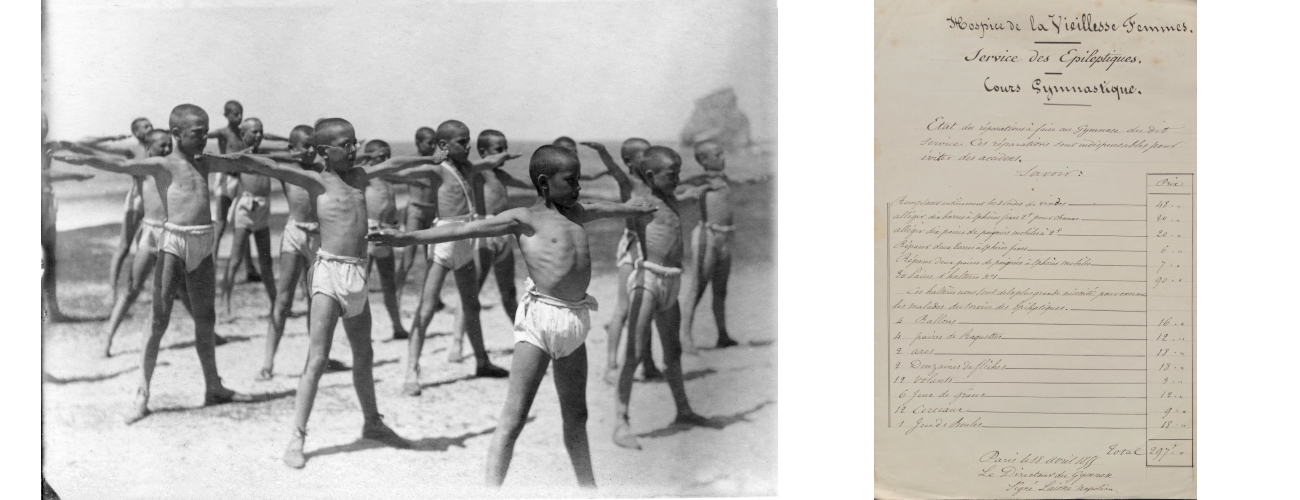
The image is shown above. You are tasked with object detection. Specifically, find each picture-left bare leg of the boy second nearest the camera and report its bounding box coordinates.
[283,294,343,469]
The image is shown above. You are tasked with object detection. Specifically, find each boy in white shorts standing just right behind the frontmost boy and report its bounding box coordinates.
[614,145,710,449]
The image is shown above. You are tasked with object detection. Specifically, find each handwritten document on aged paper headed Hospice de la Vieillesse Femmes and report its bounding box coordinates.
[875,0,1197,499]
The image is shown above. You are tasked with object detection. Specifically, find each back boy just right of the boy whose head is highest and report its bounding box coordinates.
[221,118,276,311]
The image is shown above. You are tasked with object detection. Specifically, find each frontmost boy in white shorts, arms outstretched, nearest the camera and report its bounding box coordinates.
[369,145,651,488]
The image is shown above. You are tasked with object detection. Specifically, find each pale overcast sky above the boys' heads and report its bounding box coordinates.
[43,0,776,140]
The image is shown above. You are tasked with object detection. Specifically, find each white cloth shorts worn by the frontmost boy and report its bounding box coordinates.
[515,278,598,360]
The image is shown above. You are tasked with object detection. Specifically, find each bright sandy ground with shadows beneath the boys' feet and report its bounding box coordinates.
[43,184,779,499]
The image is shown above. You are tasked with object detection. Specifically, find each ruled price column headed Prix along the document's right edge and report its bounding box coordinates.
[1147,174,1196,466]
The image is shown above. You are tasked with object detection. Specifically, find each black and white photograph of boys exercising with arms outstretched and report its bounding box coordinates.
[38,0,769,499]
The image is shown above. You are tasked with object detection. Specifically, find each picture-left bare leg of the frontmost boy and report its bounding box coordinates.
[488,342,551,487]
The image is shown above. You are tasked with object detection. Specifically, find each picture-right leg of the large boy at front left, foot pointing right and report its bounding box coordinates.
[189,256,250,404]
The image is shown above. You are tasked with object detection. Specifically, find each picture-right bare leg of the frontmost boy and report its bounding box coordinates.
[555,345,595,488]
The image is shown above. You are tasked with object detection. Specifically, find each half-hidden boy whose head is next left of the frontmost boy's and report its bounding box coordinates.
[447,129,533,362]
